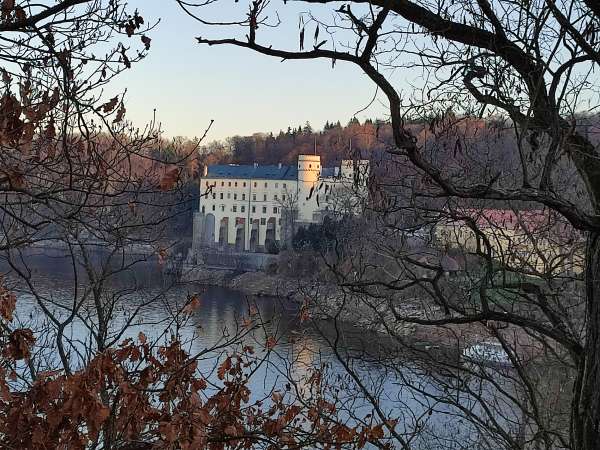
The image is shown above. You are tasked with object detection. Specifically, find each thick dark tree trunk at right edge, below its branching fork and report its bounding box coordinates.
[571,233,600,450]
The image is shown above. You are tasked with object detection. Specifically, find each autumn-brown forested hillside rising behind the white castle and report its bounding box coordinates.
[154,111,600,239]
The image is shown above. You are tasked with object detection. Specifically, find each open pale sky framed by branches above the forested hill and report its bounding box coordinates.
[112,0,385,140]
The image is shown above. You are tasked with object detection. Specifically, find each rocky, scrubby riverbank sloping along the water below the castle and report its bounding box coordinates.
[182,267,529,349]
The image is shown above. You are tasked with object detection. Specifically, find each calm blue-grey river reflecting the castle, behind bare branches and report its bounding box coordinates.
[2,255,524,449]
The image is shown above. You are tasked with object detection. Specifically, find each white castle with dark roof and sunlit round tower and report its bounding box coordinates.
[193,155,369,251]
